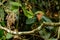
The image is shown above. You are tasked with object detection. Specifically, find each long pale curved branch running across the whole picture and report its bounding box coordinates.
[0,22,60,35]
